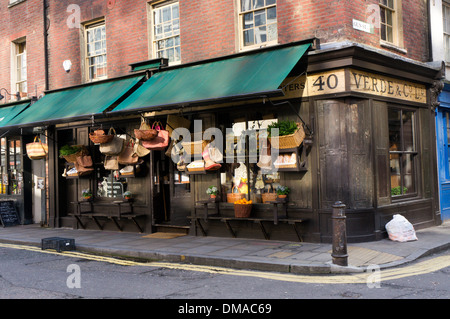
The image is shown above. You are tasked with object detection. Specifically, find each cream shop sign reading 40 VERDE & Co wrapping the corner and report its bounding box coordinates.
[280,69,427,104]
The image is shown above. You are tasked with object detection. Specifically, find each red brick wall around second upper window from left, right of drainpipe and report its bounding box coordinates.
[49,0,148,89]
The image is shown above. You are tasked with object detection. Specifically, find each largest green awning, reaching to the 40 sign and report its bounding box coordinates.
[111,44,310,113]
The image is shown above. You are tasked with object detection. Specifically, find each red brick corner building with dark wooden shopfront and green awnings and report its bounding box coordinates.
[0,0,442,242]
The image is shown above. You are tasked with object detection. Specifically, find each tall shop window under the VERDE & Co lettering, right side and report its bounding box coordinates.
[388,108,418,197]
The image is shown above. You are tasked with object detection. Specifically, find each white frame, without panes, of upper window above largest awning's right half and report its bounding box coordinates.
[237,0,278,51]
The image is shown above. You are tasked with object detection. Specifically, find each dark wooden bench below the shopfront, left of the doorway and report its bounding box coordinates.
[69,200,145,233]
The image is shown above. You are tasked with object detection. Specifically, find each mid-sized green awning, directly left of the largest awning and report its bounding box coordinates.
[4,74,143,126]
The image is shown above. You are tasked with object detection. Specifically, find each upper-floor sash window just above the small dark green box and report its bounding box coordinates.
[153,2,181,63]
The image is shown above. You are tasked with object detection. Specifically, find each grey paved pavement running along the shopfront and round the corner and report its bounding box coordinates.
[0,220,450,274]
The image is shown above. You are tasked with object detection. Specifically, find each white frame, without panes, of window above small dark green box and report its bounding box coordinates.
[150,1,181,65]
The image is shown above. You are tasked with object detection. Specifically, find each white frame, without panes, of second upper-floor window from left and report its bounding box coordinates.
[83,20,108,82]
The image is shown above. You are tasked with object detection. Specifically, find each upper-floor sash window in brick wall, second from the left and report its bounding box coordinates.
[85,21,107,81]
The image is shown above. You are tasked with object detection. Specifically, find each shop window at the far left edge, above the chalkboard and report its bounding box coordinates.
[0,138,23,195]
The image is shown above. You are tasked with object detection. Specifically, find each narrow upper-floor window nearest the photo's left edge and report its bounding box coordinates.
[12,41,28,96]
